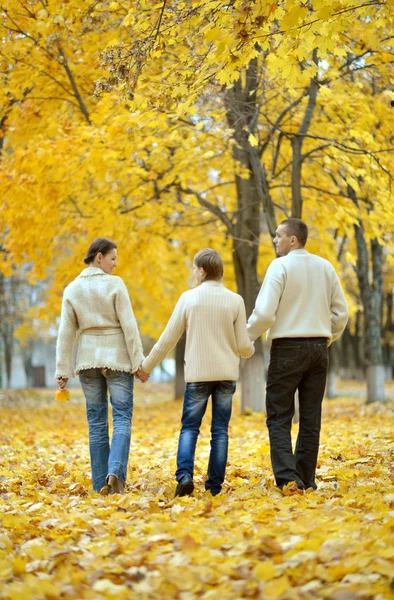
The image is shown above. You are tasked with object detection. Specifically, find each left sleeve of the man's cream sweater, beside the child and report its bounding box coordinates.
[247,261,285,340]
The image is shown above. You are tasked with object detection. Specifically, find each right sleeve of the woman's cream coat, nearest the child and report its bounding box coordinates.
[115,280,144,373]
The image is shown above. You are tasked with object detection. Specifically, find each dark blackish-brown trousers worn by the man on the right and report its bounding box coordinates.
[266,338,328,489]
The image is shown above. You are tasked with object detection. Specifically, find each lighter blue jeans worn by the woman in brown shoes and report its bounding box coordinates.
[79,369,134,492]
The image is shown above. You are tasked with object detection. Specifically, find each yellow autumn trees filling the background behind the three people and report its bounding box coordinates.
[0,1,394,410]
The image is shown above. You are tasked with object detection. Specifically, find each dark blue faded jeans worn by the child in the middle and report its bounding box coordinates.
[176,381,236,493]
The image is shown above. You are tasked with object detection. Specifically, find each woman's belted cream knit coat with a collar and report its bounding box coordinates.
[55,267,144,378]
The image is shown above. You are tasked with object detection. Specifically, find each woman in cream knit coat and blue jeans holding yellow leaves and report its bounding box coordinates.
[55,238,147,494]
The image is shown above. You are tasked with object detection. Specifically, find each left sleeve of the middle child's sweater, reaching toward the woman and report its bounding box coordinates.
[142,294,186,373]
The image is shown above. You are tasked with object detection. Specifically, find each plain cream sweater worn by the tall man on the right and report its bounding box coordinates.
[248,249,349,343]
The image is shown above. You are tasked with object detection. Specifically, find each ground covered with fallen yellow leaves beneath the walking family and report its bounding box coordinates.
[0,384,394,600]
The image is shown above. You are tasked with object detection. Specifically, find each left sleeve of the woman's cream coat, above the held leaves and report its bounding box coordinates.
[55,292,79,379]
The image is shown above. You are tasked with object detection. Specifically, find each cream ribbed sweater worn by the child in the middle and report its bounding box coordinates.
[142,281,254,383]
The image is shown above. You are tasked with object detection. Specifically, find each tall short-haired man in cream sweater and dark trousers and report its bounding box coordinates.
[248,219,348,493]
